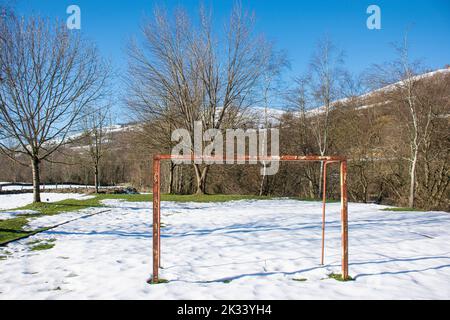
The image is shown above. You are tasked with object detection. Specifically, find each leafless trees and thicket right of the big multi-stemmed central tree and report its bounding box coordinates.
[282,37,450,210]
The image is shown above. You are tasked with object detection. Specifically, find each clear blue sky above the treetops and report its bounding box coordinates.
[15,0,450,117]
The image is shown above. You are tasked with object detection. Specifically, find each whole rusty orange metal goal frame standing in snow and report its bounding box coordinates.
[149,154,348,283]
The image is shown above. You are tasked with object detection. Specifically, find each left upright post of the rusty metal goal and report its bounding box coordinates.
[152,157,161,283]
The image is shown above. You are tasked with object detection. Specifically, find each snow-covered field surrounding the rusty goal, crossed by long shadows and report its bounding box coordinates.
[0,199,450,299]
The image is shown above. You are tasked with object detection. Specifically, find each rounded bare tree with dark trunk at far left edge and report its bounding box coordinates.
[0,17,106,202]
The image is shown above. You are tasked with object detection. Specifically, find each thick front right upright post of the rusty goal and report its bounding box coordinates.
[341,161,348,280]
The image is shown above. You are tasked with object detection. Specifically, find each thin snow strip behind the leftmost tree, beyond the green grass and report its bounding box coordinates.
[0,192,92,212]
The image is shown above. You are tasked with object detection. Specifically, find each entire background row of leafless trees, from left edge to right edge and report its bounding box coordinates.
[0,6,450,210]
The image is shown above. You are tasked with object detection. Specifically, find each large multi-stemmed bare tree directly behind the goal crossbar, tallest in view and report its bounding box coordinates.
[129,6,270,193]
